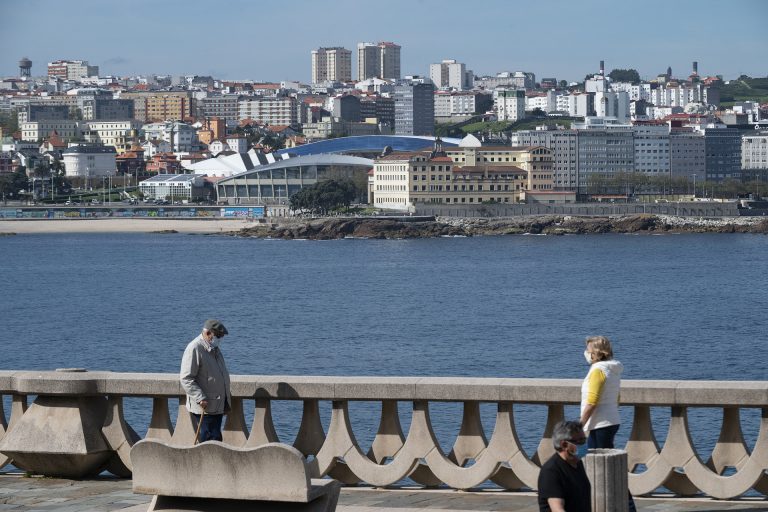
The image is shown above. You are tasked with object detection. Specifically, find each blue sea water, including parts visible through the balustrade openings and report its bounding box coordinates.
[0,234,768,472]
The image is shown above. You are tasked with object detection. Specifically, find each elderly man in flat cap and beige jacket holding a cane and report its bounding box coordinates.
[179,319,232,442]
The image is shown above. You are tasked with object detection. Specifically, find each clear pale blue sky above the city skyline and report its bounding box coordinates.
[0,0,768,83]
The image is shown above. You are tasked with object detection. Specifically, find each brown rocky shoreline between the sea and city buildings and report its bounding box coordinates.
[230,215,768,240]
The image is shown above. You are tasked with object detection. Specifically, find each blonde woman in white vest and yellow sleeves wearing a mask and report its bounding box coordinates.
[581,336,624,448]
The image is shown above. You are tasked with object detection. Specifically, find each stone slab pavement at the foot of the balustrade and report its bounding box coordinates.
[0,473,768,512]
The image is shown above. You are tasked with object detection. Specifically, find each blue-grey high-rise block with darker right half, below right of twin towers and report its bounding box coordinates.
[394,79,435,135]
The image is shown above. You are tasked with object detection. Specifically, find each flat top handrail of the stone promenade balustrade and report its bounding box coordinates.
[0,370,768,408]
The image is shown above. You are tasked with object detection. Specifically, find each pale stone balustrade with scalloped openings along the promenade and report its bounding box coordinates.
[0,371,768,498]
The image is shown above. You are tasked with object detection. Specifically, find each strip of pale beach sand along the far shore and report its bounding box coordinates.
[0,217,259,235]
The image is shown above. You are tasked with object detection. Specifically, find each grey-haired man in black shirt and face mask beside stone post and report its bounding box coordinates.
[538,421,592,512]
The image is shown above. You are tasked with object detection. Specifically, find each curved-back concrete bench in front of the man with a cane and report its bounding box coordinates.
[131,439,341,512]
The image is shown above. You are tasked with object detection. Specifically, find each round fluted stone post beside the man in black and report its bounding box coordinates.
[584,448,629,512]
